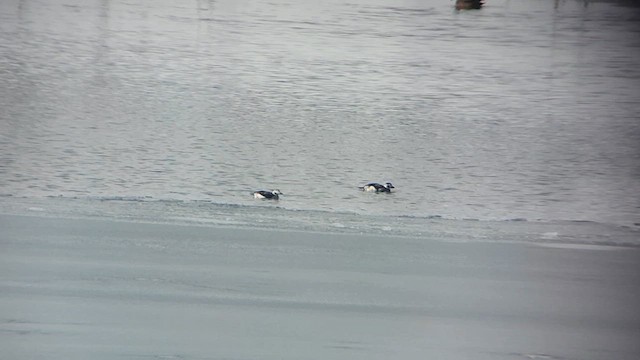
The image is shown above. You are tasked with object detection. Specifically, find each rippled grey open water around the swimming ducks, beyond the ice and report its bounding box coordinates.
[0,0,640,241]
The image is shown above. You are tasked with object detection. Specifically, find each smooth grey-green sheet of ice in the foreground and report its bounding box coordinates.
[0,215,640,360]
